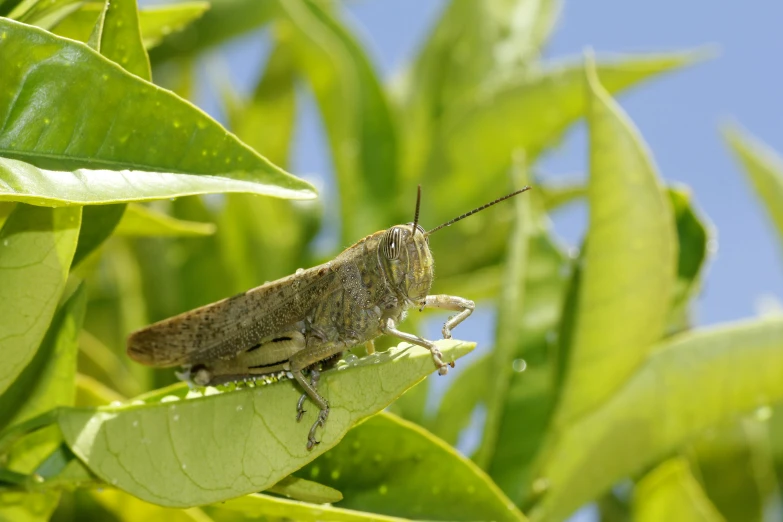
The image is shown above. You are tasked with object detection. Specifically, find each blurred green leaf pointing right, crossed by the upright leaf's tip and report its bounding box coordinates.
[434,52,704,223]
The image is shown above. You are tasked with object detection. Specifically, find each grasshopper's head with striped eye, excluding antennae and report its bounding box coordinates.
[378,223,434,303]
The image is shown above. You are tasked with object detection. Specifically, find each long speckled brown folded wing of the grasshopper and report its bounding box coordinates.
[128,263,340,367]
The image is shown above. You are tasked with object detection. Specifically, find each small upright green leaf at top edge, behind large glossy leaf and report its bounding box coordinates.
[97,0,152,81]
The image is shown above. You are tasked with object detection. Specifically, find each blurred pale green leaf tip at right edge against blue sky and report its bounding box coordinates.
[723,125,783,250]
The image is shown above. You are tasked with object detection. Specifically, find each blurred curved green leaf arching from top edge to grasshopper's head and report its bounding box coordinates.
[279,0,398,243]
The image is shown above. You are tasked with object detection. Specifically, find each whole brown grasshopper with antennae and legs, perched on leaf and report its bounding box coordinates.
[127,187,530,449]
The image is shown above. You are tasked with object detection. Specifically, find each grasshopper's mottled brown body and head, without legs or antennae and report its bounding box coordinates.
[128,223,433,374]
